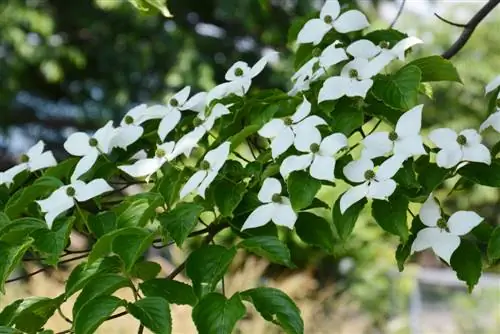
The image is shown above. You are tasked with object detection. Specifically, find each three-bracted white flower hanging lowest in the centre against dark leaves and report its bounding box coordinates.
[241,177,297,231]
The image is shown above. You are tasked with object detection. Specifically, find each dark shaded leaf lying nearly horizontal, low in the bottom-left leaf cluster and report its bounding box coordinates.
[139,278,198,306]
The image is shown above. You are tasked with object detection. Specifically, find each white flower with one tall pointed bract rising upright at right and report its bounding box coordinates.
[361,104,426,159]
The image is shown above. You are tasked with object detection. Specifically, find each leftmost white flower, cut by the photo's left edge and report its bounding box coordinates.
[0,140,57,186]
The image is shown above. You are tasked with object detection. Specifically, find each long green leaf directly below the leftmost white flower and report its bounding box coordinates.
[5,176,63,219]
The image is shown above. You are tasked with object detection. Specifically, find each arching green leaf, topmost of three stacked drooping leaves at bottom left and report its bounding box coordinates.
[64,256,121,299]
